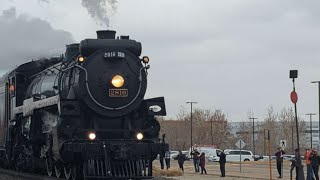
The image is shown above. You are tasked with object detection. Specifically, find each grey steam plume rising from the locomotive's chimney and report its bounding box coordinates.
[81,0,117,27]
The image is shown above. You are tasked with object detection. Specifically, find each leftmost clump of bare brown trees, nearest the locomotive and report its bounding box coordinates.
[160,108,230,150]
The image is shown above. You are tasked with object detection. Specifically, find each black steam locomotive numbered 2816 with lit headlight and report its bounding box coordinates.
[0,30,168,179]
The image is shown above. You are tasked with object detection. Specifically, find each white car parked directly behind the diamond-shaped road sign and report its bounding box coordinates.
[225,150,254,162]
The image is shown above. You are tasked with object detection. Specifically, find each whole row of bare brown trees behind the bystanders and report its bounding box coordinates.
[158,106,307,155]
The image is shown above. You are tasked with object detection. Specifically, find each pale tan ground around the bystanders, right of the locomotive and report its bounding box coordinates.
[154,160,298,180]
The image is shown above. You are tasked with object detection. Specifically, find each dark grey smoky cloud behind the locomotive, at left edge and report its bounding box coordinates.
[0,7,74,70]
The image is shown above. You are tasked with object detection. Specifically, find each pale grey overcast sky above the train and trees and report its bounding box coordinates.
[0,0,320,121]
